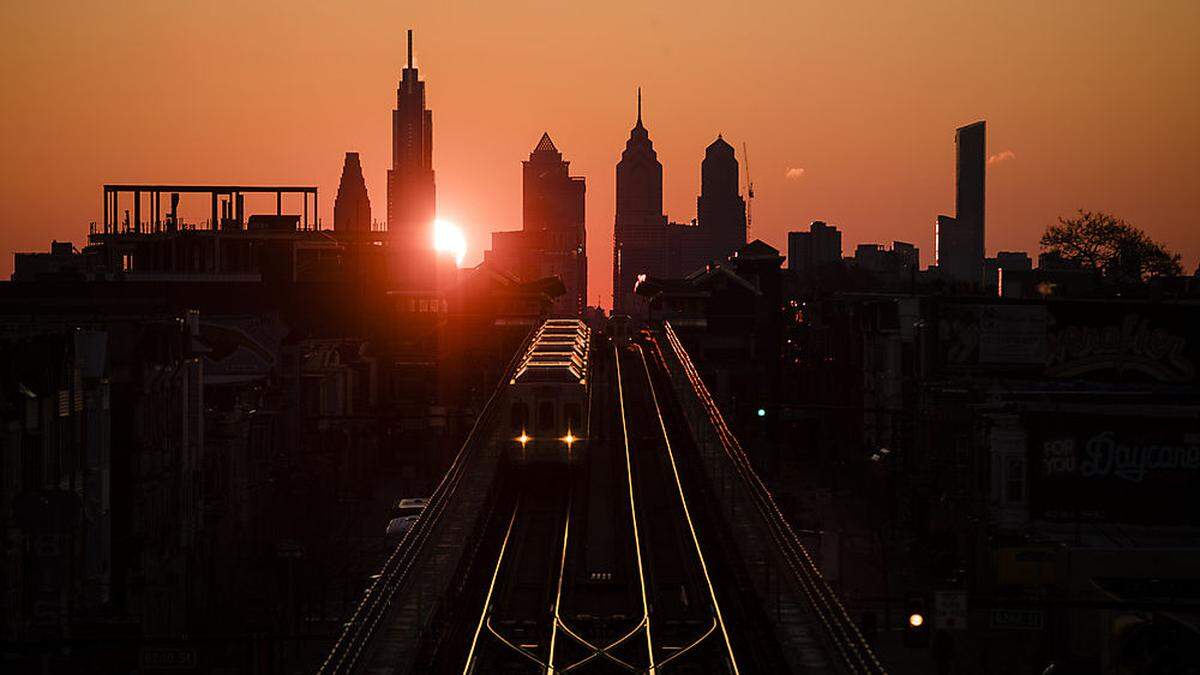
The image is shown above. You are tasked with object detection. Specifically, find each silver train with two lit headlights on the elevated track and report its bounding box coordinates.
[508,318,592,464]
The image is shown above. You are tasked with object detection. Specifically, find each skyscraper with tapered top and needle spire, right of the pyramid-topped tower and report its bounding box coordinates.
[612,89,667,313]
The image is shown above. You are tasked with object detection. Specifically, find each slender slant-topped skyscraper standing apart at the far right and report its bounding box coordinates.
[937,121,988,283]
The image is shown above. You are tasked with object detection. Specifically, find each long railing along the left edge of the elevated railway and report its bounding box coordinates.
[317,330,536,675]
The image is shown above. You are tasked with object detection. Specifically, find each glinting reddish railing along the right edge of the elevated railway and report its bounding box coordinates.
[654,322,886,674]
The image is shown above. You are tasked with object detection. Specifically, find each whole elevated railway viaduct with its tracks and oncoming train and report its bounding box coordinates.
[322,321,882,674]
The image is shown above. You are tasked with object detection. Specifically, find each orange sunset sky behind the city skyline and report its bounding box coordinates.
[0,0,1200,305]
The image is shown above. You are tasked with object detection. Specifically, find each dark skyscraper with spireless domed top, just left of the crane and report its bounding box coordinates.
[696,135,746,259]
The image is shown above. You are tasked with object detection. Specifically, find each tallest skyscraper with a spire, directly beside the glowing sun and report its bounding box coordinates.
[388,30,437,267]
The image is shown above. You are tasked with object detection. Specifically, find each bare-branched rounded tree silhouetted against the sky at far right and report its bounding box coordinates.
[1040,209,1183,285]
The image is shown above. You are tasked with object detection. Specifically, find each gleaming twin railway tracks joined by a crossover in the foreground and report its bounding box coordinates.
[461,345,743,675]
